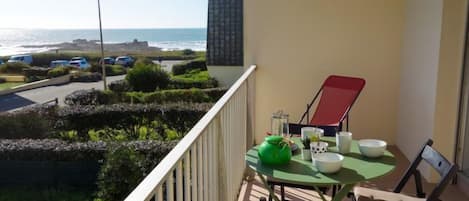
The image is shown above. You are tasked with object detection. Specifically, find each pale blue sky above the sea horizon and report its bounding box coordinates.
[0,0,208,29]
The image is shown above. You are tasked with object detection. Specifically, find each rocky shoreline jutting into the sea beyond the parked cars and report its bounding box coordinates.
[21,39,161,52]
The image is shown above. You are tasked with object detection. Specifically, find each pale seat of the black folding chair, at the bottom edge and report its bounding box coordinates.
[353,187,425,201]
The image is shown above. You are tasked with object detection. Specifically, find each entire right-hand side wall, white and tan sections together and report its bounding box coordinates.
[397,0,466,181]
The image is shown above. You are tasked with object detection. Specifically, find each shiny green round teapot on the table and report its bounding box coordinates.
[258,136,291,165]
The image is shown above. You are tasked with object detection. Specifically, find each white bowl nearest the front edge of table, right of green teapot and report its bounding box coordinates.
[313,152,344,173]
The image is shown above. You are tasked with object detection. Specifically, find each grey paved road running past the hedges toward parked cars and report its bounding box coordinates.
[0,61,182,112]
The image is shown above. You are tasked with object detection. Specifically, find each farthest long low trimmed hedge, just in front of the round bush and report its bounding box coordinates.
[65,88,226,106]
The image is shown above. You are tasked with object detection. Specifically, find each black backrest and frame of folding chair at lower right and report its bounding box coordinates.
[394,139,458,201]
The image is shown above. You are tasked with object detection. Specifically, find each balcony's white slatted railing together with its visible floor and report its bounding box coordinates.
[126,66,469,201]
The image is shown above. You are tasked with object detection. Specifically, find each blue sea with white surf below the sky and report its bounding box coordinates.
[0,28,207,56]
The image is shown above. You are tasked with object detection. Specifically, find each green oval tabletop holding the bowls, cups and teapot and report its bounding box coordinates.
[245,137,396,186]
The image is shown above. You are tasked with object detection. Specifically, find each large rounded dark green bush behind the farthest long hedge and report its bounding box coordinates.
[125,64,170,92]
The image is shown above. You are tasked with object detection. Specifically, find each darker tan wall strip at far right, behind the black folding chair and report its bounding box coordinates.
[432,0,467,181]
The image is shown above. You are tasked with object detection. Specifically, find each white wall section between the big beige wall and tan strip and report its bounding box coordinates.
[396,0,443,179]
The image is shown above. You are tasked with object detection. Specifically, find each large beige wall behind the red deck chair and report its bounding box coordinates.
[244,0,404,144]
